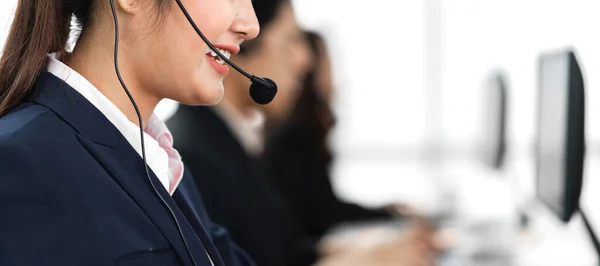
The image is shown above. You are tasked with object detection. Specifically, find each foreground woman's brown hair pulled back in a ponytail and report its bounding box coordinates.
[0,0,170,116]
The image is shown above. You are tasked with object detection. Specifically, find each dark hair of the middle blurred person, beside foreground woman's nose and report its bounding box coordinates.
[240,0,291,54]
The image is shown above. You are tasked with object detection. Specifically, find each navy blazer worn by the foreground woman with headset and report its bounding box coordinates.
[0,72,252,266]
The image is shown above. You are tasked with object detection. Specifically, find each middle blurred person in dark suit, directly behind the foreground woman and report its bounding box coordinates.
[168,0,438,266]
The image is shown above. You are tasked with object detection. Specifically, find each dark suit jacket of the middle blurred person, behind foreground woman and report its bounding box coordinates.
[167,105,316,266]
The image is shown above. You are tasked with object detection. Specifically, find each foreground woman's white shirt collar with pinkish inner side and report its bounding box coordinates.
[47,55,183,195]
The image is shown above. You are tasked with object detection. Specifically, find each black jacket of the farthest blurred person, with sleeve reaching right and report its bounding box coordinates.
[263,120,392,237]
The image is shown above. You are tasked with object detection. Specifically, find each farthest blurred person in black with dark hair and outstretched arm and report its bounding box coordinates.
[263,32,407,237]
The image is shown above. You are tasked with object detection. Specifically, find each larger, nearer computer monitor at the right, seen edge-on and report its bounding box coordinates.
[536,48,585,223]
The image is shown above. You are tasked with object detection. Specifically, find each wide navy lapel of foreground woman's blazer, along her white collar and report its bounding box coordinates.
[30,72,213,265]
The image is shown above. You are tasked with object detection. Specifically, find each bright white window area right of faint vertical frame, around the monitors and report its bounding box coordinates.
[442,0,600,154]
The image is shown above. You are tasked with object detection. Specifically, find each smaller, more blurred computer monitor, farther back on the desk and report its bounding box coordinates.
[479,70,508,170]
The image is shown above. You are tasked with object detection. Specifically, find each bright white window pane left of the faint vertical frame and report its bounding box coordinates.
[294,0,427,153]
